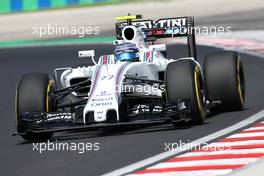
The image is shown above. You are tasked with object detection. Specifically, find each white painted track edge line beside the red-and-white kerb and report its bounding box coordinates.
[103,110,264,176]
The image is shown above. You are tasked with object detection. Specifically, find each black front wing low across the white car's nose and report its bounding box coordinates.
[14,103,189,135]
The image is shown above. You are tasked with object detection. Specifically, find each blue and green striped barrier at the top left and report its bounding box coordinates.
[0,0,126,13]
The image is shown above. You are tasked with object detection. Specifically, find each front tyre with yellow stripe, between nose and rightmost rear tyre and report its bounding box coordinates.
[165,59,206,124]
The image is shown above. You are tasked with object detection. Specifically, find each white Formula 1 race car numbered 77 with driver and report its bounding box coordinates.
[16,15,245,140]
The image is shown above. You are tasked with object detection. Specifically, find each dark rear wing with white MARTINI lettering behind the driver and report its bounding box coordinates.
[115,15,197,59]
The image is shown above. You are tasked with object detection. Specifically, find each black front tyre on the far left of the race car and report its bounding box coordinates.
[16,73,53,141]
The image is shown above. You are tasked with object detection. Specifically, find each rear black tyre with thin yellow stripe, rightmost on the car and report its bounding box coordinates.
[204,51,245,112]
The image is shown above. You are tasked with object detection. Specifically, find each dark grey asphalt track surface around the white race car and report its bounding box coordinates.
[0,45,264,176]
